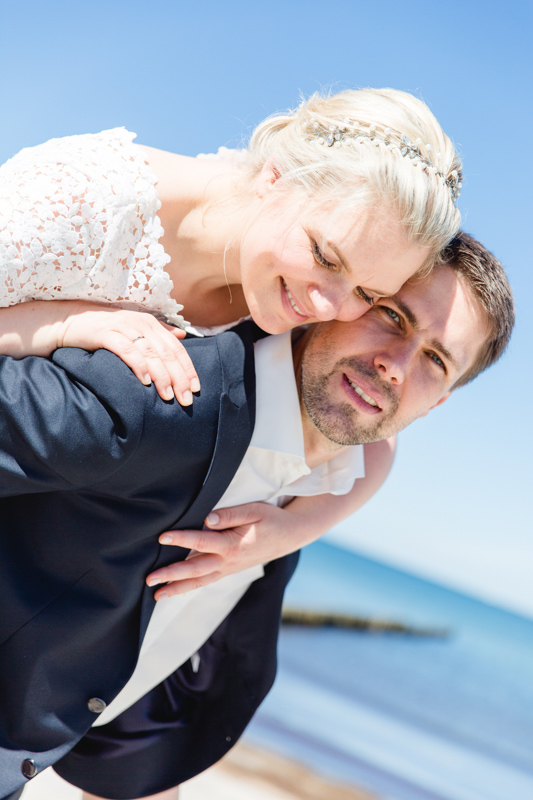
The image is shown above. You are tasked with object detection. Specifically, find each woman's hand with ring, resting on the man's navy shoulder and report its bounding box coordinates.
[57,302,200,406]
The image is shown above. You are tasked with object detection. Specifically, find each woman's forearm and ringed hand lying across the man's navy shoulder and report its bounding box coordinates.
[0,300,200,405]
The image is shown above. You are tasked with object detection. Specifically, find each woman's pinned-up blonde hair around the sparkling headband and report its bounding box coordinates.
[243,89,461,259]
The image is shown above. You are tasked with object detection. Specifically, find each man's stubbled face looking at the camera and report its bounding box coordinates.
[300,265,487,445]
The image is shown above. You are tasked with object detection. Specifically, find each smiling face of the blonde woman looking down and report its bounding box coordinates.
[238,192,429,333]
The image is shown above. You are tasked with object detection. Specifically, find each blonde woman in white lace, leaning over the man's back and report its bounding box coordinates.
[0,89,461,598]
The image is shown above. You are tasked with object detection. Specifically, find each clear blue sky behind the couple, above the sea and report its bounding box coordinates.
[0,0,533,616]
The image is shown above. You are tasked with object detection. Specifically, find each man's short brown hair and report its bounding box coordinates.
[439,231,515,389]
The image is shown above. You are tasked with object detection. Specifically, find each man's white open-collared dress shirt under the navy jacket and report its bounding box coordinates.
[94,332,364,725]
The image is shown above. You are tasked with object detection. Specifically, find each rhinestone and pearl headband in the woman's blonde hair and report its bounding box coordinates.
[310,119,463,203]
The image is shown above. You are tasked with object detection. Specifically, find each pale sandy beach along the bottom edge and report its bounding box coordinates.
[23,742,378,800]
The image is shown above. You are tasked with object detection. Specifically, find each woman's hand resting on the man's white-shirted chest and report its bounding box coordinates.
[146,503,309,600]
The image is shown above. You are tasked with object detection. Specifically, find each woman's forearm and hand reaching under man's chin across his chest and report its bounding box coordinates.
[146,438,396,600]
